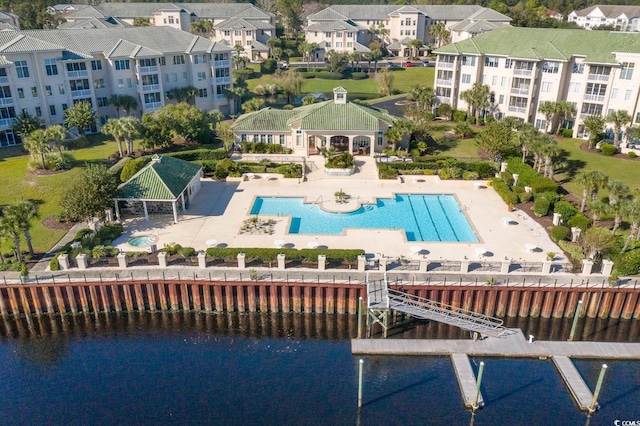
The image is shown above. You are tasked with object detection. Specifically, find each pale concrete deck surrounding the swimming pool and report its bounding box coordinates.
[114,159,565,262]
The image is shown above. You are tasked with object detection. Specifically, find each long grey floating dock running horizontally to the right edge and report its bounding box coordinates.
[351,329,640,360]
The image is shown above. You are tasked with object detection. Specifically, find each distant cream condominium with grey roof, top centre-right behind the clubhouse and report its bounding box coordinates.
[304,5,511,58]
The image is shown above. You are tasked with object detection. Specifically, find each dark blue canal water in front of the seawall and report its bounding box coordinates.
[0,313,640,425]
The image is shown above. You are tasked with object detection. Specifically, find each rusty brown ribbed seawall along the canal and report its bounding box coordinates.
[0,280,640,319]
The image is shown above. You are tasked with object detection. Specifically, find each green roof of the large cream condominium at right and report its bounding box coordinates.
[435,28,640,64]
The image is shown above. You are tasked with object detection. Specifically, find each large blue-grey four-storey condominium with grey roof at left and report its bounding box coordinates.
[0,27,232,146]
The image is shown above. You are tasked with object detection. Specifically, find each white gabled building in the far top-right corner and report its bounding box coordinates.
[567,4,640,31]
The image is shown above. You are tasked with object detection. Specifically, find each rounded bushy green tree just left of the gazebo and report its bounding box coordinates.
[60,164,118,221]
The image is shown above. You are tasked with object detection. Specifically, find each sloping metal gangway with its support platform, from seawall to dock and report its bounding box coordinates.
[367,276,510,337]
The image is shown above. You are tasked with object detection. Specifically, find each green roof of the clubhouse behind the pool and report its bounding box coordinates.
[231,100,396,132]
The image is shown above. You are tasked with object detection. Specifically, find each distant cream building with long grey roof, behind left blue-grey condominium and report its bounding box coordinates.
[60,3,276,58]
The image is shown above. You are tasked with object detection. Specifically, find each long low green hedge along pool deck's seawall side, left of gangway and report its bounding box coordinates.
[207,247,364,262]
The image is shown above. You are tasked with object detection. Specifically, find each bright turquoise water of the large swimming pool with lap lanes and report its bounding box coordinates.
[250,194,478,243]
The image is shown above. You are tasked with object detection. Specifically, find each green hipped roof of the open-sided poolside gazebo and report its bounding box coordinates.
[114,155,202,201]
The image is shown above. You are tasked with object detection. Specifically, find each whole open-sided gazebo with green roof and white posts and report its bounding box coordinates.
[113,155,202,223]
